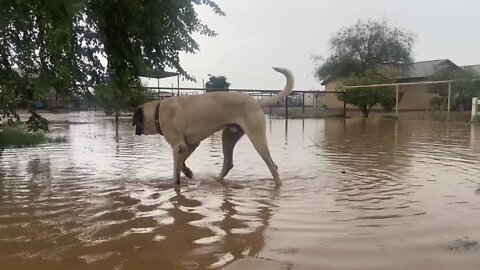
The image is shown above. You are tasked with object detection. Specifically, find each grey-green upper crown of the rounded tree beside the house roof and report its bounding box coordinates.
[315,20,415,80]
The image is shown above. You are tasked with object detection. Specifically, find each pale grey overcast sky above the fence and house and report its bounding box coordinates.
[142,0,480,90]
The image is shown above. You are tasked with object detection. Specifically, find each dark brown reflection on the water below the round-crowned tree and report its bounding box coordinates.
[325,119,412,172]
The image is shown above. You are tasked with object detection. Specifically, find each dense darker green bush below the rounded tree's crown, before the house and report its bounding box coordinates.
[337,70,395,118]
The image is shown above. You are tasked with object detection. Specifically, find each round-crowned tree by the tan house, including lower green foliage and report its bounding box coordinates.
[315,17,415,117]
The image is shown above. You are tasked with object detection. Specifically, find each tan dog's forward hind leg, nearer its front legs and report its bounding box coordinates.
[217,126,244,181]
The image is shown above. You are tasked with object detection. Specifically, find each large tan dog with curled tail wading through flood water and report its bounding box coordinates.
[132,68,294,186]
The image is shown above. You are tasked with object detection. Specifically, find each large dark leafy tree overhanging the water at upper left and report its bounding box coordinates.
[0,0,224,131]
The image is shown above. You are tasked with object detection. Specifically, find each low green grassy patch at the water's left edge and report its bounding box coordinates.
[0,128,67,148]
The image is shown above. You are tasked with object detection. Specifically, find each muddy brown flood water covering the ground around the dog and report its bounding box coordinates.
[0,115,480,270]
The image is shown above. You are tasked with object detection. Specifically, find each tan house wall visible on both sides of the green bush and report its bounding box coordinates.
[325,82,438,110]
